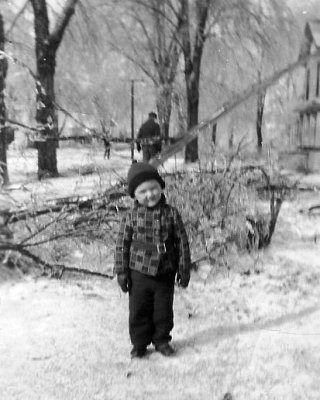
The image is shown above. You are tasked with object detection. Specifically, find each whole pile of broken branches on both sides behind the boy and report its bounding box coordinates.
[0,165,293,278]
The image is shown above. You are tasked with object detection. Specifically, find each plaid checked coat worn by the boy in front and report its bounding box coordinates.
[114,195,191,276]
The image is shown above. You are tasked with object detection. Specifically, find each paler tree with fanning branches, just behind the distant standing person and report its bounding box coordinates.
[105,0,182,143]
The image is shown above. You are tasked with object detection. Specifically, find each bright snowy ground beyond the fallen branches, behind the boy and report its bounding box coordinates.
[0,144,183,208]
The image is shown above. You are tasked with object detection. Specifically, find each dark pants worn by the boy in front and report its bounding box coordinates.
[129,271,174,347]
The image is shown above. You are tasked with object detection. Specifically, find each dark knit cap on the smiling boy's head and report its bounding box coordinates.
[128,162,165,198]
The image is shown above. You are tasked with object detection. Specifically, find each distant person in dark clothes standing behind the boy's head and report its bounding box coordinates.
[137,112,161,162]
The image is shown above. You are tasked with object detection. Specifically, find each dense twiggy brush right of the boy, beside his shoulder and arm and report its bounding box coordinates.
[166,159,290,265]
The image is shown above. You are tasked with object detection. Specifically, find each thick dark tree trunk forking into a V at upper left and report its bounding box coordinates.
[30,0,78,179]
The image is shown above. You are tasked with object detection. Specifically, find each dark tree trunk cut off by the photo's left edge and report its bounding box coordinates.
[0,14,9,184]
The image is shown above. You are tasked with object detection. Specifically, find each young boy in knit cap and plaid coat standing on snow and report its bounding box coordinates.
[115,162,191,358]
